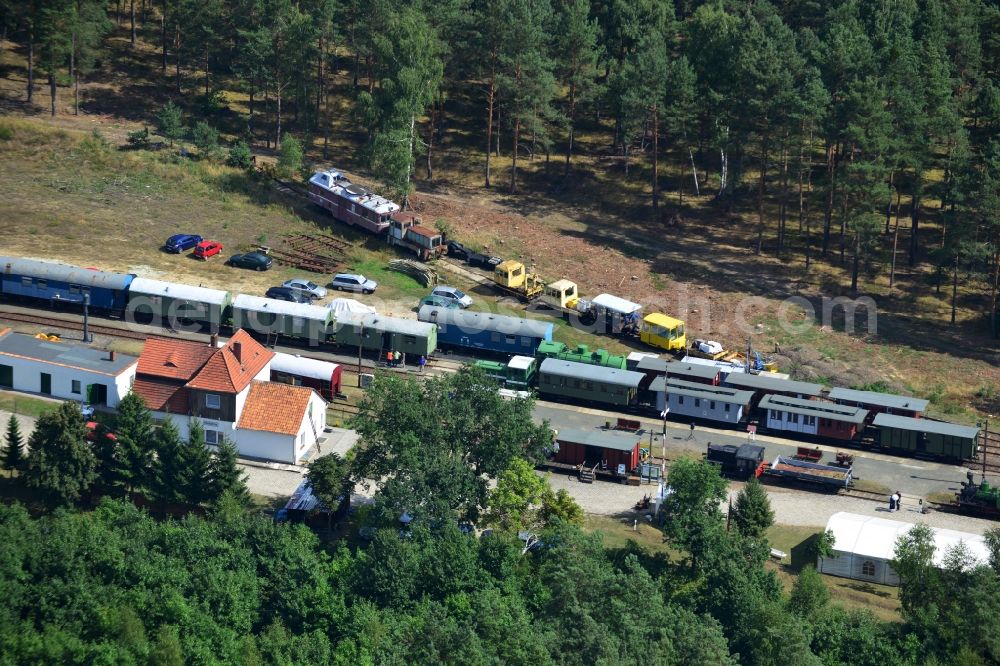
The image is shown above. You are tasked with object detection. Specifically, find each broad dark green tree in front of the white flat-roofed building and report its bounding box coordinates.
[23,401,97,506]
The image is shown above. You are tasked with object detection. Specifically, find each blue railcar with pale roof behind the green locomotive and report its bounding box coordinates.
[417,305,553,356]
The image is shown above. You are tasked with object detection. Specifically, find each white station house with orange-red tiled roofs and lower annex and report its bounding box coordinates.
[133,330,326,464]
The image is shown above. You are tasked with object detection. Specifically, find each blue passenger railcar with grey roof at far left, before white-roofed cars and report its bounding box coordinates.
[0,257,135,315]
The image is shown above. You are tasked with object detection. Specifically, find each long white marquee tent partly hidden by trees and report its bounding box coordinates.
[816,511,989,585]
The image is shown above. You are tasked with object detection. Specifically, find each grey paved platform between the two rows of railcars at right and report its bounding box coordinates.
[535,401,980,497]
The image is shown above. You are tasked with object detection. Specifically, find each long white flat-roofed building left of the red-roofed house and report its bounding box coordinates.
[0,329,139,407]
